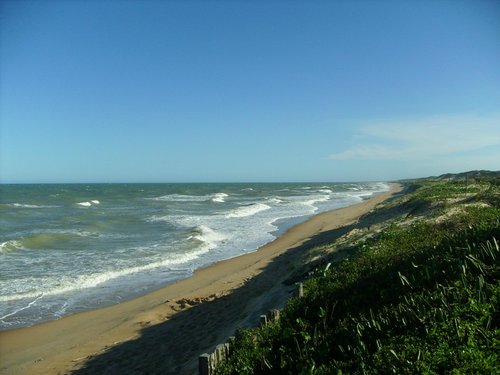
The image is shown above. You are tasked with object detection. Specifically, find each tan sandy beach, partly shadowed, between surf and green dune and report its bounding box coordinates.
[0,185,401,375]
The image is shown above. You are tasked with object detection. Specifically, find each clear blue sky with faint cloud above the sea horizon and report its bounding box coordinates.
[0,0,500,183]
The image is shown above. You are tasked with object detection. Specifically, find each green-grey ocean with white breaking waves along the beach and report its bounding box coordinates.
[0,182,388,329]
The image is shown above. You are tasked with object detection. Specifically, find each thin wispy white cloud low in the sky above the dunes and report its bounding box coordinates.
[330,114,500,161]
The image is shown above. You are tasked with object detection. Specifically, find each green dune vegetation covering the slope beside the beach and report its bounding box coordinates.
[216,172,500,374]
